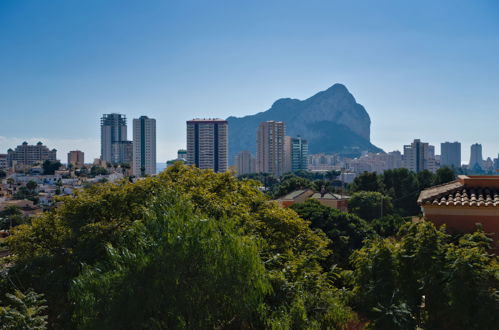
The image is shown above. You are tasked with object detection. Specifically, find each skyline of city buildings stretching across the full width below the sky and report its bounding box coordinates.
[0,113,499,176]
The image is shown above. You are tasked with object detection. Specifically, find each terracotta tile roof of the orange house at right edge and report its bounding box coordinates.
[418,180,499,207]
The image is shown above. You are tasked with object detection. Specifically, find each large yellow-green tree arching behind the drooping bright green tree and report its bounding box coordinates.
[7,164,351,328]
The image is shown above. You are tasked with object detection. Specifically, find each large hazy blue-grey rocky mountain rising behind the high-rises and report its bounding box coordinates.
[227,84,382,163]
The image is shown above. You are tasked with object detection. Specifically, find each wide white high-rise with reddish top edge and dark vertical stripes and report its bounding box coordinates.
[187,119,229,172]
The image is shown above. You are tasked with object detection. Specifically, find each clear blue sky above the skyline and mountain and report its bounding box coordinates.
[0,0,499,162]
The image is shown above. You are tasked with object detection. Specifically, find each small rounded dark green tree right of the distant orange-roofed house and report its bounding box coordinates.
[348,191,393,221]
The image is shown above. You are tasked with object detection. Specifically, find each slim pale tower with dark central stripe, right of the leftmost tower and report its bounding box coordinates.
[132,116,156,176]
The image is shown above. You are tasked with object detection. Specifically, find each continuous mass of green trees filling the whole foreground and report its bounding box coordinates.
[0,165,499,329]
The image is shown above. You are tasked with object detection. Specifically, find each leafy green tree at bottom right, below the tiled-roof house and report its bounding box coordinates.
[351,221,499,330]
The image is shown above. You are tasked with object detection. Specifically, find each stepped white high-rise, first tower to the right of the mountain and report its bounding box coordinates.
[404,139,437,173]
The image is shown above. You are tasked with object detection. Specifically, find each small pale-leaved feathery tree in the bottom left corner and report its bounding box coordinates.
[0,290,47,330]
